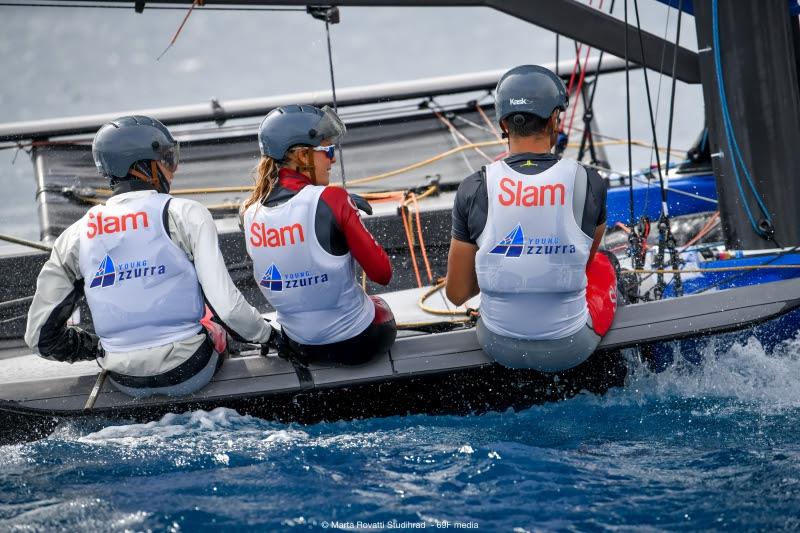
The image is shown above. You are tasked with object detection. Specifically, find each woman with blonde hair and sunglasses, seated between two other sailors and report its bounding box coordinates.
[242,105,397,365]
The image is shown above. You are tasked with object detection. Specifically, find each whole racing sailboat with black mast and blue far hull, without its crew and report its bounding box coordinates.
[0,0,800,441]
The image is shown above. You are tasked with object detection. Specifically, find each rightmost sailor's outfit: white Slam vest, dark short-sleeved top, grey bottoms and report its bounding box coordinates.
[453,153,616,371]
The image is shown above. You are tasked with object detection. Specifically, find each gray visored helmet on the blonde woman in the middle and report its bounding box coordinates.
[258,105,347,161]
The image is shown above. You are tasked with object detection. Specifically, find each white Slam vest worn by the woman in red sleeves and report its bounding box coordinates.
[243,185,375,345]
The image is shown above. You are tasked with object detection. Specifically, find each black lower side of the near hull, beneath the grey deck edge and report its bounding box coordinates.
[0,351,627,445]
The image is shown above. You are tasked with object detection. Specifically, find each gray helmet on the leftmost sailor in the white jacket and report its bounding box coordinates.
[92,116,178,178]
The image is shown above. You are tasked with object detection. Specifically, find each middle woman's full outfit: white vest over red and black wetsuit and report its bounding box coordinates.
[243,168,397,365]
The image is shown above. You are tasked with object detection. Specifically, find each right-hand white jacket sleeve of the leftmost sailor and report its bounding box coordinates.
[169,198,272,343]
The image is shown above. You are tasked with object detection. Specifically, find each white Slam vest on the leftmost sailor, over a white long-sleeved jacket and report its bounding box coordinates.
[79,193,204,352]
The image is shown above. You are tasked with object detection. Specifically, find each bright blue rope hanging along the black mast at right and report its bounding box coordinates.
[711,0,772,237]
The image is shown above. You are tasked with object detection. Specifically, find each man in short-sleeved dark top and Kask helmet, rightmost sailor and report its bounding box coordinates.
[446,65,616,372]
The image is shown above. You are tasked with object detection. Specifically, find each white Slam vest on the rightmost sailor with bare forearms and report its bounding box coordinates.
[475,159,592,339]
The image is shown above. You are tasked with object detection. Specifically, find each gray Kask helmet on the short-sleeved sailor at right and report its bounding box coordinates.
[494,65,569,122]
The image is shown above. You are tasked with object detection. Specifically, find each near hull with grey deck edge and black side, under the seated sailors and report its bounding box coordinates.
[0,280,800,443]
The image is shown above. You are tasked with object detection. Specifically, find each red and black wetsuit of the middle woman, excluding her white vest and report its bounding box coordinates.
[264,168,397,365]
